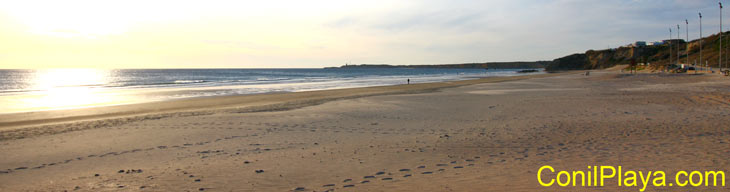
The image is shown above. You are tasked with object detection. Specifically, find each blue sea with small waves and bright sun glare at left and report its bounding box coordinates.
[0,68,535,113]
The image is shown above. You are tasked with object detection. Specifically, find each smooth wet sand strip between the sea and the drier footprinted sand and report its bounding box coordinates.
[0,71,568,135]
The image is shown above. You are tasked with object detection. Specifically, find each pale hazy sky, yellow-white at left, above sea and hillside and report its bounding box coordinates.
[0,0,730,68]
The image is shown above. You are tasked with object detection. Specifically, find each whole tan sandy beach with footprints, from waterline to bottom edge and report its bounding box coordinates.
[0,71,730,191]
